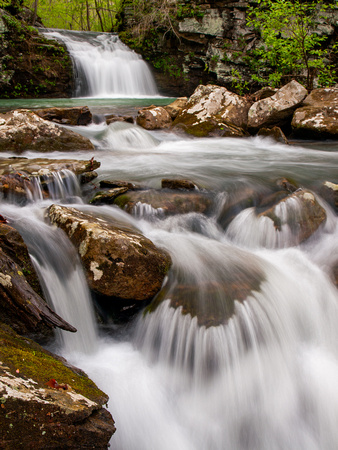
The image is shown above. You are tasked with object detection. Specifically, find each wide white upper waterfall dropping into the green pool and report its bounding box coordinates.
[41,29,158,98]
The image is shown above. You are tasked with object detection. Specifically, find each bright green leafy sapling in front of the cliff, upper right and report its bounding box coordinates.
[248,0,336,89]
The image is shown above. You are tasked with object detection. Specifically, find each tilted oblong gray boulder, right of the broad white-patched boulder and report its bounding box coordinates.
[248,80,307,130]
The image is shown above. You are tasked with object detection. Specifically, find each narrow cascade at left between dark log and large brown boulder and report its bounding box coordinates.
[2,202,98,354]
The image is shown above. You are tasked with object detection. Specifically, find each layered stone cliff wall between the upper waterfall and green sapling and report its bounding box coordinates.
[123,0,338,95]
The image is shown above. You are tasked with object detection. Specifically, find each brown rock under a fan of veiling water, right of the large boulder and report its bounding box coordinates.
[147,244,265,327]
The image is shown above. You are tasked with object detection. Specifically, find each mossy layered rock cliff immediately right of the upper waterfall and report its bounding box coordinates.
[121,0,338,95]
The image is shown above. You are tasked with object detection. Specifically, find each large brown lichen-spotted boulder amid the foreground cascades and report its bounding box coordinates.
[48,205,171,302]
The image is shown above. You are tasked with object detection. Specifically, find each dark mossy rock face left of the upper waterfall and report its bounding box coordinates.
[0,9,73,98]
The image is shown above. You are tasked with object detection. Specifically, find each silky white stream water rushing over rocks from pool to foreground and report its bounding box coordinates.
[1,29,338,450]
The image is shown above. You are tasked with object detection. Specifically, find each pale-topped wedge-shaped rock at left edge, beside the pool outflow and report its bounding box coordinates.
[0,109,94,154]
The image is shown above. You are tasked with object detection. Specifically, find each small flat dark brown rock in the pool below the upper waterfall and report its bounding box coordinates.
[34,106,93,125]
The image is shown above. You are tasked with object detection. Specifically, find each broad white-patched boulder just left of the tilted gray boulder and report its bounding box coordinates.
[173,85,250,137]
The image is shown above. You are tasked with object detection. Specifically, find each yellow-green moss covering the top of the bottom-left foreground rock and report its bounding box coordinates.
[0,324,105,401]
